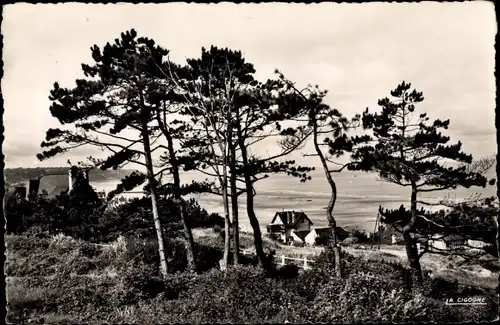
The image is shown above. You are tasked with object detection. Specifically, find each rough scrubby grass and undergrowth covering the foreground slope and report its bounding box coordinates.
[5,229,493,324]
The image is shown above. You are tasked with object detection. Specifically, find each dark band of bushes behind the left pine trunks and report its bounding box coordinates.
[5,187,222,243]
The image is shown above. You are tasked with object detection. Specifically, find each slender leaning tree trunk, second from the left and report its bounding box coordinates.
[162,121,197,272]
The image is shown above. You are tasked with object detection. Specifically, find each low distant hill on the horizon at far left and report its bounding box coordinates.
[4,167,133,184]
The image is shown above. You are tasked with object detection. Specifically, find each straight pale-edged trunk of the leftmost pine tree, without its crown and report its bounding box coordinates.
[142,123,168,277]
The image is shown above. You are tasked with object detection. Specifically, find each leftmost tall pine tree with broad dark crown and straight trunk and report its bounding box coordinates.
[37,30,184,276]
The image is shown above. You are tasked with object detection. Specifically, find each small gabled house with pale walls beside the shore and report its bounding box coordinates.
[267,211,313,243]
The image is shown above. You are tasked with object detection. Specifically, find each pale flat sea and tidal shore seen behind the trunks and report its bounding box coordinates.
[92,170,496,232]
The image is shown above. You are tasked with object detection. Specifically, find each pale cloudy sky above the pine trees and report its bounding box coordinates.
[1,1,497,168]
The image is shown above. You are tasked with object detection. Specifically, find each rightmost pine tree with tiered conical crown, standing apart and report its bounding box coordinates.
[348,82,487,282]
